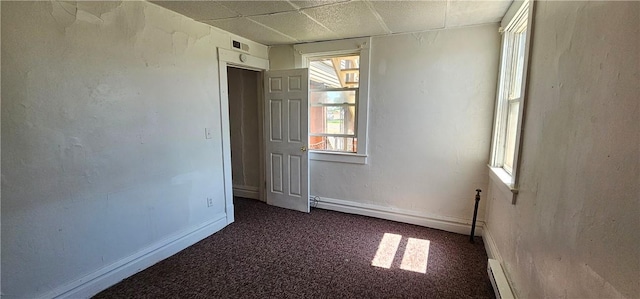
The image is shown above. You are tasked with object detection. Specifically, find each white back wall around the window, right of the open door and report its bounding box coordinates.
[270,24,499,233]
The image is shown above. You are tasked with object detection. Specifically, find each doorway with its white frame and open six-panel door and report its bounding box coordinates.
[218,48,309,220]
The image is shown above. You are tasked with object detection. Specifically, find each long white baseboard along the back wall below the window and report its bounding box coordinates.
[316,197,484,236]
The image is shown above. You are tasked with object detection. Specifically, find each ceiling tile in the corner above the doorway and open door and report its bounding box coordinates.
[202,18,296,45]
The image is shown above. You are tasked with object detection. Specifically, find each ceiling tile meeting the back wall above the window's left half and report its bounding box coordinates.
[250,11,338,42]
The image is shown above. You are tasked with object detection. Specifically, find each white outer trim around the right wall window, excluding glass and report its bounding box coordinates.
[489,0,534,204]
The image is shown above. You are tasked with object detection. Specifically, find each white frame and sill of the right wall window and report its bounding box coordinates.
[489,0,534,204]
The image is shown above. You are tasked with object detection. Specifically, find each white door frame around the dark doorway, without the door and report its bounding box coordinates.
[218,48,269,224]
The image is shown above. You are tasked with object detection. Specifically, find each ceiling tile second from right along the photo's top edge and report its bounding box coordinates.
[371,1,447,33]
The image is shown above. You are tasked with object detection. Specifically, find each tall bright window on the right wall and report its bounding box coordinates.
[491,1,532,193]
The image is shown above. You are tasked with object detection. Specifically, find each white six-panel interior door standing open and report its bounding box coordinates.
[263,69,309,213]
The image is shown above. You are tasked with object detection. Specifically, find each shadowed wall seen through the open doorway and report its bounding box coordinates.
[227,67,262,198]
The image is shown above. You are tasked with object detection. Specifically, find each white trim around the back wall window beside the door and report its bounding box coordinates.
[293,38,371,164]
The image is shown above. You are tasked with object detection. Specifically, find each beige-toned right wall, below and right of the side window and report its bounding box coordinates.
[486,1,640,298]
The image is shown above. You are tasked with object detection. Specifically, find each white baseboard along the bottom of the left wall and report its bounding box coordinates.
[39,213,227,298]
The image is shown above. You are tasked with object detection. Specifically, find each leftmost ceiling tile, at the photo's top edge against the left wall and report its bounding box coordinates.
[151,1,239,20]
